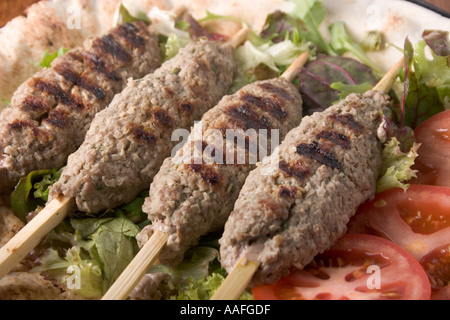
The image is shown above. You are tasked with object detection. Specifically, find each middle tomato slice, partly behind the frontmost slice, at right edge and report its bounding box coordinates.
[348,185,450,299]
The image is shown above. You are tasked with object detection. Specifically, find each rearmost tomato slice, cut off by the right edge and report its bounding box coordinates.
[410,110,450,187]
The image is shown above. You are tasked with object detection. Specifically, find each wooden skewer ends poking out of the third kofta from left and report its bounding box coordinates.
[103,51,309,300]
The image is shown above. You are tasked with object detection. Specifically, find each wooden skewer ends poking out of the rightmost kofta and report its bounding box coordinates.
[211,59,403,300]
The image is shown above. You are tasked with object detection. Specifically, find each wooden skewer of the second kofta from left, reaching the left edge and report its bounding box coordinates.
[0,5,212,279]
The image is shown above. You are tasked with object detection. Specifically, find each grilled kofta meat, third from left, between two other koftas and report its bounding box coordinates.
[138,78,302,265]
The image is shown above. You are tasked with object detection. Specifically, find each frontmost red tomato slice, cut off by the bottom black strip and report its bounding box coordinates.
[253,234,431,300]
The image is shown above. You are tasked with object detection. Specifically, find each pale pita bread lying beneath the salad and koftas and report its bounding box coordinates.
[0,0,450,299]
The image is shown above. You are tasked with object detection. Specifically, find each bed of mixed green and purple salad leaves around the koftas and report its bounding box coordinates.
[11,0,450,299]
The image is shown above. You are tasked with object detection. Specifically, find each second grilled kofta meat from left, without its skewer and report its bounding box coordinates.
[50,39,236,214]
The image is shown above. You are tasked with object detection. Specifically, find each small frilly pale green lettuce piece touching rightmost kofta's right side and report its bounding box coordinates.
[377,137,420,193]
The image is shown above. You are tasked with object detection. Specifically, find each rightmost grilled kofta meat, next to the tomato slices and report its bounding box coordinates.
[219,91,389,285]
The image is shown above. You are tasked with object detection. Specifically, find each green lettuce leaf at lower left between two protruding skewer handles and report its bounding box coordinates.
[31,217,140,298]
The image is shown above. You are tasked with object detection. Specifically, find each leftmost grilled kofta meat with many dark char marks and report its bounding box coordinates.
[0,22,160,193]
